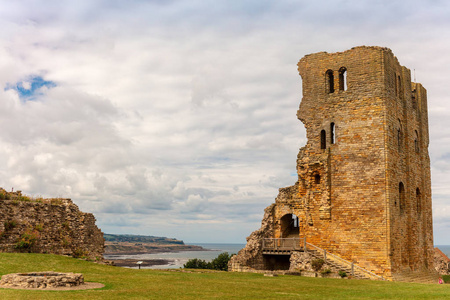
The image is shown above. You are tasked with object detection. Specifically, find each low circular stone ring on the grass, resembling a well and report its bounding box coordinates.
[0,272,84,288]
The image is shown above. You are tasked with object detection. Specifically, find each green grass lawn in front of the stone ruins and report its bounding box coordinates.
[0,253,450,300]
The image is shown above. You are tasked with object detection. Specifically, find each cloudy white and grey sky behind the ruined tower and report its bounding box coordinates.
[0,0,450,244]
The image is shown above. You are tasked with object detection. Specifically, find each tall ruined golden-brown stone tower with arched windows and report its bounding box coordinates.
[231,46,433,280]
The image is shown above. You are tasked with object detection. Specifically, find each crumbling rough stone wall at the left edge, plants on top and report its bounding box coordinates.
[0,188,105,260]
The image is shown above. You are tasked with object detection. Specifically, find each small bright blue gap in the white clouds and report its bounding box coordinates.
[5,75,56,101]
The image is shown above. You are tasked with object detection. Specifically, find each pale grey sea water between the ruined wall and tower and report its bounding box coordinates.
[105,243,245,269]
